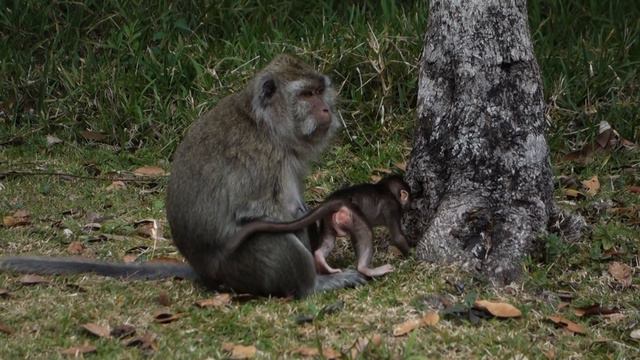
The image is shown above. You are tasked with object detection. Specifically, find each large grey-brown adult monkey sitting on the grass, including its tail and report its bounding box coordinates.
[0,55,365,297]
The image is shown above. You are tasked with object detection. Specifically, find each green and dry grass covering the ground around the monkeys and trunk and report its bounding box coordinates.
[0,0,640,358]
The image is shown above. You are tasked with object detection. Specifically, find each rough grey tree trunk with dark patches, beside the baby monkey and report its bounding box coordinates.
[404,0,554,284]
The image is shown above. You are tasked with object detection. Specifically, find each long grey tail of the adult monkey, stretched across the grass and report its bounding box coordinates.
[0,256,197,280]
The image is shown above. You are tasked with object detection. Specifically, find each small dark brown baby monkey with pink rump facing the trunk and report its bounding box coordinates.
[226,175,411,277]
